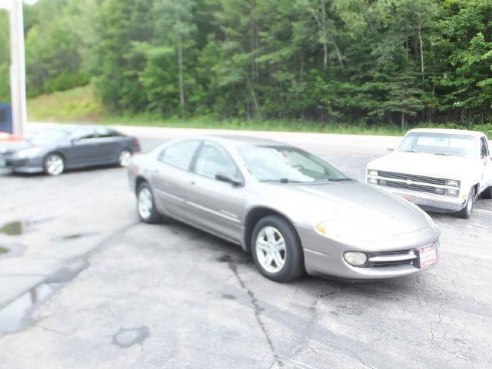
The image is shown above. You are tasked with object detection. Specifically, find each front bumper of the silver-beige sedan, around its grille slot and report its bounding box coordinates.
[298,227,439,280]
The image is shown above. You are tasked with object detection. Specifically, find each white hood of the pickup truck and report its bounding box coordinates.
[367,152,477,179]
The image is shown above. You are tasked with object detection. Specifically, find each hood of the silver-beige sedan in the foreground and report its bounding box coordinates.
[262,181,434,239]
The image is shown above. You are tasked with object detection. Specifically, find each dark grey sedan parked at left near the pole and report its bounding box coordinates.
[0,125,140,175]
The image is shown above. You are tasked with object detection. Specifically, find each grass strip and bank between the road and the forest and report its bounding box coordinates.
[27,85,492,137]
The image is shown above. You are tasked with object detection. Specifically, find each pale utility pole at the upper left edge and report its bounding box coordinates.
[0,0,27,135]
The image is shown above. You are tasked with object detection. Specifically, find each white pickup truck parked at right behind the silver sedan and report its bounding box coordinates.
[366,129,492,218]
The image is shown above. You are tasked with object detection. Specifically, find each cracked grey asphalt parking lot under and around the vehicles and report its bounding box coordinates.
[0,130,492,369]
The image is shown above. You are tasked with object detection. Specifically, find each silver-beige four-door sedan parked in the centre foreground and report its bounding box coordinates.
[129,136,440,282]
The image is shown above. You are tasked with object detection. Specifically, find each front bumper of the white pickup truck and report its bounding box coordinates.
[377,186,467,212]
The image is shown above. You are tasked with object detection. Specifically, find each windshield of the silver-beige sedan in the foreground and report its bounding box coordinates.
[239,146,350,183]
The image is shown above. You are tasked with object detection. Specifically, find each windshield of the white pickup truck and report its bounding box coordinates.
[398,132,477,158]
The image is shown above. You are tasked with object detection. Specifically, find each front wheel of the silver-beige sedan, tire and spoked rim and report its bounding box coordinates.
[251,215,304,282]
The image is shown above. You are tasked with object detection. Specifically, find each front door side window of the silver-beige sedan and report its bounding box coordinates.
[195,143,238,178]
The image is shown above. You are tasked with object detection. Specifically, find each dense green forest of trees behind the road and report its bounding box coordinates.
[0,0,492,125]
